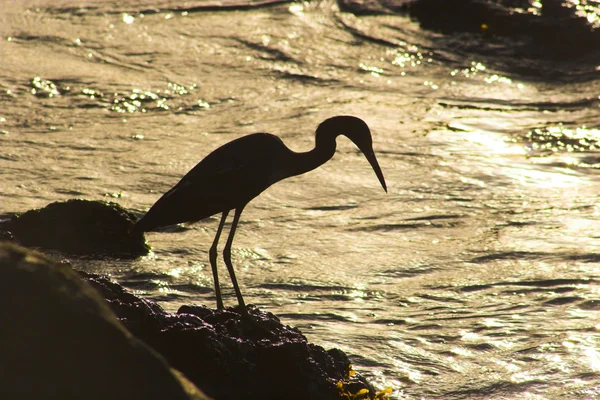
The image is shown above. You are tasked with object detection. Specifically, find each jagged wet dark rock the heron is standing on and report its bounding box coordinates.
[82,273,375,400]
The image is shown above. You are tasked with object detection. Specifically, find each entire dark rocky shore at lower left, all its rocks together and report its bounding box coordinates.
[0,200,387,399]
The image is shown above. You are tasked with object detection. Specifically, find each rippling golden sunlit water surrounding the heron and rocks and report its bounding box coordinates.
[0,0,600,399]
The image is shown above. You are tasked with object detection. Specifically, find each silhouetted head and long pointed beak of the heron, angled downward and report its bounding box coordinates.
[317,115,387,192]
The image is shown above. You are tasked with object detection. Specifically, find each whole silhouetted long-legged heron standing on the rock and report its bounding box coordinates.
[130,115,387,314]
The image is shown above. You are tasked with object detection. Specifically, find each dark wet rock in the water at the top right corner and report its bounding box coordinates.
[402,0,600,61]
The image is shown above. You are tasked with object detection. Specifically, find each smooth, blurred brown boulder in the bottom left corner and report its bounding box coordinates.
[0,242,207,400]
